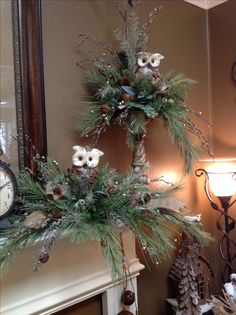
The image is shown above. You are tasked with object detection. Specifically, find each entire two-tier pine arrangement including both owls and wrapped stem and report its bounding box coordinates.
[1,1,211,278]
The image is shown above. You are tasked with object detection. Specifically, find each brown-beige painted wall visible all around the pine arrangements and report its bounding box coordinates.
[42,0,236,315]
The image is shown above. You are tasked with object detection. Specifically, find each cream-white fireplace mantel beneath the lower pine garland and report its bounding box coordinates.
[0,232,144,315]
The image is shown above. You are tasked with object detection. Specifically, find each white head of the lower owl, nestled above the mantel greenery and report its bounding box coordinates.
[72,145,104,168]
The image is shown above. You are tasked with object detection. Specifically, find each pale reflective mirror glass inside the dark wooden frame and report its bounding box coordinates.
[0,1,18,170]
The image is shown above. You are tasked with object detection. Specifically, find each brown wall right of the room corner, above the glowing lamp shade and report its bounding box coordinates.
[210,0,236,158]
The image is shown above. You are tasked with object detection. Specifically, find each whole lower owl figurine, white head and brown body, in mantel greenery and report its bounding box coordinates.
[71,145,104,186]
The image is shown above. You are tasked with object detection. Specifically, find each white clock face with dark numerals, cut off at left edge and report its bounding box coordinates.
[0,162,16,219]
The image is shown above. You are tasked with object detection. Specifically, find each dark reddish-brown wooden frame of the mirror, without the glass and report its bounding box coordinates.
[12,0,47,170]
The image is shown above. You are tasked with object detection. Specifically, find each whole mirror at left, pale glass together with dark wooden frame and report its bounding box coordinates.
[0,0,47,169]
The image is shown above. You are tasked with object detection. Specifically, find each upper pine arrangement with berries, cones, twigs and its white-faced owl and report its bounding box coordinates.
[78,1,209,173]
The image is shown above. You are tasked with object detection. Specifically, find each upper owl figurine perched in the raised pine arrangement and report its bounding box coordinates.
[137,52,164,85]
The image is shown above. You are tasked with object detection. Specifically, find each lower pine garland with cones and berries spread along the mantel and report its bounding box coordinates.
[1,158,211,278]
